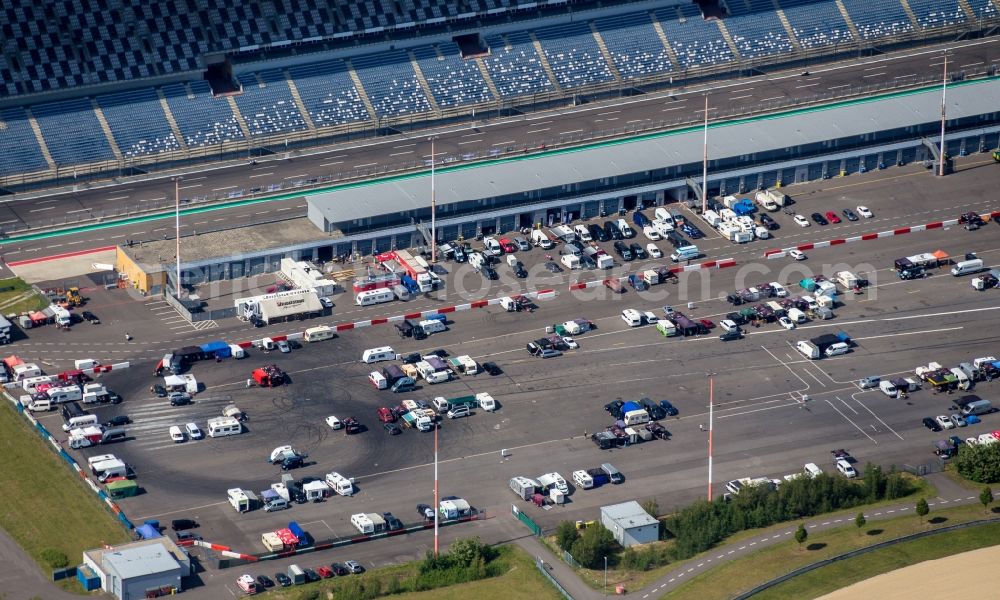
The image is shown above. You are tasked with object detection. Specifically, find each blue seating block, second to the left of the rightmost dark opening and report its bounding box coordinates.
[594,13,674,79]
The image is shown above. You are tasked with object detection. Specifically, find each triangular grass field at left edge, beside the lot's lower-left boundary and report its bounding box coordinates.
[0,398,130,574]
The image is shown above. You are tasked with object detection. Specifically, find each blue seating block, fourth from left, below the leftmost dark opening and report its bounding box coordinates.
[162,81,244,148]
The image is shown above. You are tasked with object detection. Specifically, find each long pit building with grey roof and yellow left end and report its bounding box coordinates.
[120,77,1000,291]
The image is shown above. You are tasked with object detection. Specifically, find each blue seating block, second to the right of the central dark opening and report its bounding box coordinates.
[535,23,614,89]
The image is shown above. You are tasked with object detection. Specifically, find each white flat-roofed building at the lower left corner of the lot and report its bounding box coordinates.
[83,537,191,600]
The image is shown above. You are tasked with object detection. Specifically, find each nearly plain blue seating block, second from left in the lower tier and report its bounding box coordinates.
[31,98,115,166]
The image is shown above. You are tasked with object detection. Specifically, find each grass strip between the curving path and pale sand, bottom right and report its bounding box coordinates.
[663,504,997,600]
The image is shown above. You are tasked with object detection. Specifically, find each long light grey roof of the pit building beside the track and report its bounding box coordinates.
[308,80,1000,228]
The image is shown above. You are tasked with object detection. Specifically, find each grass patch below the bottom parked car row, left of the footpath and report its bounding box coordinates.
[264,545,562,600]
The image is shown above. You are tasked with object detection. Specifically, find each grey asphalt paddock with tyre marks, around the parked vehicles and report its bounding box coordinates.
[15,158,1000,596]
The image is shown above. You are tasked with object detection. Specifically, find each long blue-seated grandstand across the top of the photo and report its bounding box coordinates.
[0,0,1000,193]
